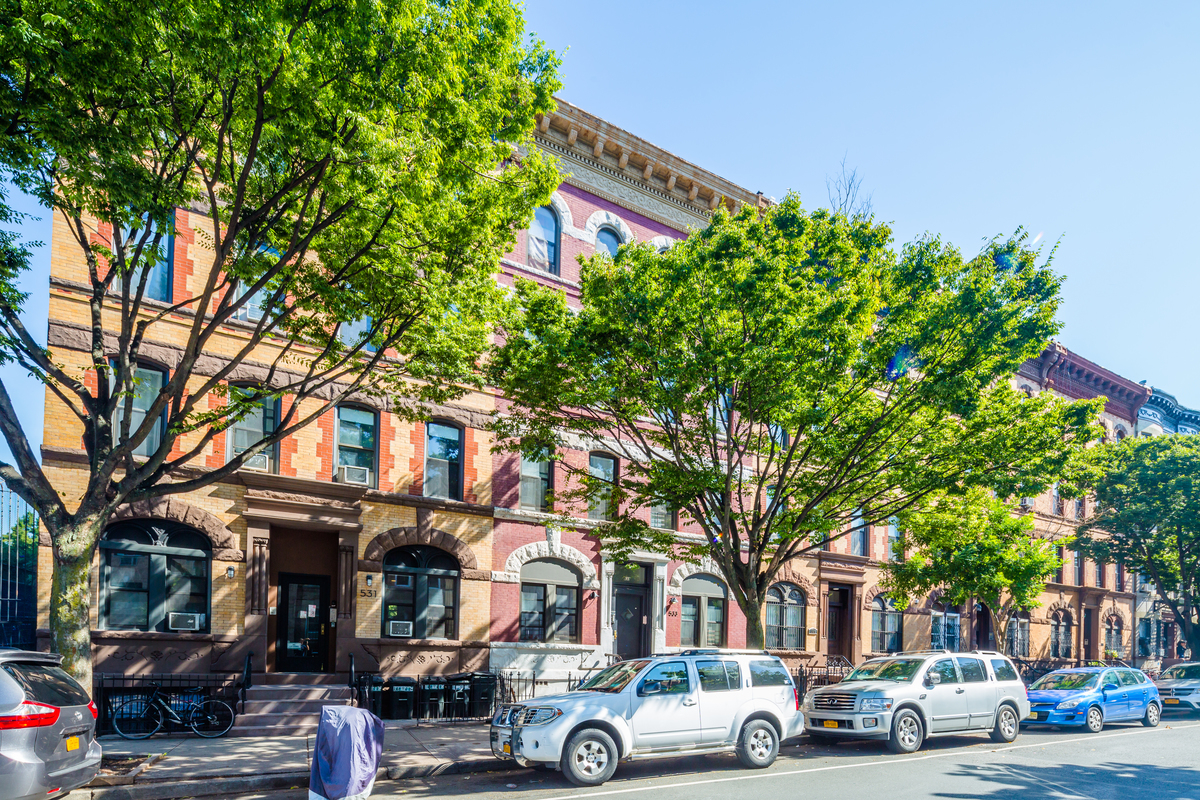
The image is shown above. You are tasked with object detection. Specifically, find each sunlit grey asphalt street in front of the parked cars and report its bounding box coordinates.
[225,717,1200,800]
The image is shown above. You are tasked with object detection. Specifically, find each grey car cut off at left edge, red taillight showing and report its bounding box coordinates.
[0,648,101,800]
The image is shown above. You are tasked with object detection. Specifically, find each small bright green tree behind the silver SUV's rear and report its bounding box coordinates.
[881,488,1062,646]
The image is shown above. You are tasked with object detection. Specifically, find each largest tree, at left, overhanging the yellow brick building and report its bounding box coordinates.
[0,0,558,685]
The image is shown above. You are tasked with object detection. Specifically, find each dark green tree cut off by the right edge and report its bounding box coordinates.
[1072,435,1200,655]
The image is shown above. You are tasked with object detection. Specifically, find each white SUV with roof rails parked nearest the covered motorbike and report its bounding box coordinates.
[491,650,803,786]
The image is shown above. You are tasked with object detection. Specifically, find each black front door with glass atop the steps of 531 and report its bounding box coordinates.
[275,573,329,672]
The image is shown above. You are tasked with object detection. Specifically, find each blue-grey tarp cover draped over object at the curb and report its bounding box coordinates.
[308,705,383,800]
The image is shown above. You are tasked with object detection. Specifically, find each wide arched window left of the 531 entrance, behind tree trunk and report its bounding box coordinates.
[98,519,212,633]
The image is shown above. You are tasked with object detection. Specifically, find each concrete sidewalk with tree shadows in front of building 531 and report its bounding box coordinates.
[83,722,515,800]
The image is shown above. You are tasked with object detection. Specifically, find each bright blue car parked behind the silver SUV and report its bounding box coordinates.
[1021,667,1163,733]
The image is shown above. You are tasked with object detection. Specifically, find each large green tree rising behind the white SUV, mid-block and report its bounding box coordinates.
[491,197,1098,648]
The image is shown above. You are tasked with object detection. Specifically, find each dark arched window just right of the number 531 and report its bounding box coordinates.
[383,545,458,639]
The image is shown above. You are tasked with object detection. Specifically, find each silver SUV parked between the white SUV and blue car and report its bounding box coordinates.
[804,650,1030,753]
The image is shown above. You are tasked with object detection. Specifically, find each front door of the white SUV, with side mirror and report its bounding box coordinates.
[630,661,701,750]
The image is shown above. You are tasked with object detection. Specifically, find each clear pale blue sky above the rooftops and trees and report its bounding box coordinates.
[0,0,1200,457]
